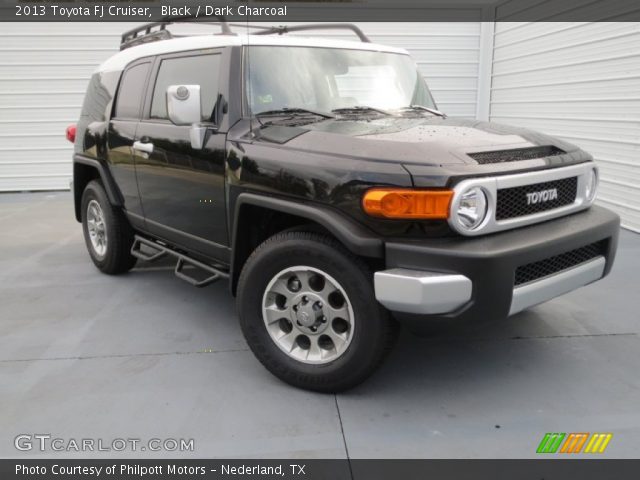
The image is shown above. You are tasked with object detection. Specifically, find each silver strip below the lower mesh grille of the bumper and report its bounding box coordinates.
[509,257,606,315]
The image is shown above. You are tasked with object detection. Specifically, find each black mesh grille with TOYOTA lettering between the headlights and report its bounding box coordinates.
[496,177,578,220]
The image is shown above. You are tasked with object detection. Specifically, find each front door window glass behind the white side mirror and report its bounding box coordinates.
[151,54,220,121]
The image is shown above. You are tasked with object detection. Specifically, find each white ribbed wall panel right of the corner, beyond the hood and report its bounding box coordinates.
[491,23,640,231]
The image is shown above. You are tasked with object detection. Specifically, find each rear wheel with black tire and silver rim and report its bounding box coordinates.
[82,180,136,275]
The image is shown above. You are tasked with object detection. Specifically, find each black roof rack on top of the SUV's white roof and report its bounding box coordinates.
[120,16,371,50]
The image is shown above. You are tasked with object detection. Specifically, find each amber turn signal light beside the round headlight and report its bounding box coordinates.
[362,188,453,220]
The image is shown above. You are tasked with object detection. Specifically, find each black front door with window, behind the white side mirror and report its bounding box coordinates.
[135,49,229,263]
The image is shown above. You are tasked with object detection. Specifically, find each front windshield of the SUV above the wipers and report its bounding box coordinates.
[245,46,435,115]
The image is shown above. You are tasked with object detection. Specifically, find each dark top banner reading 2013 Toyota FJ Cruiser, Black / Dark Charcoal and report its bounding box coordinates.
[0,0,640,24]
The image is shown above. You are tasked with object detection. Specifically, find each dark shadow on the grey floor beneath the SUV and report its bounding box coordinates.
[131,260,580,394]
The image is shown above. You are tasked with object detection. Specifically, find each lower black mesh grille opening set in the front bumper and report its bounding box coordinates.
[514,240,607,287]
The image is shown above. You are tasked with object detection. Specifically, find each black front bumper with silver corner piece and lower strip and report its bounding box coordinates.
[374,206,620,326]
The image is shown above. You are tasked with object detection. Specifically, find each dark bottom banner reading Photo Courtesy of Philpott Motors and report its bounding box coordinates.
[0,458,640,480]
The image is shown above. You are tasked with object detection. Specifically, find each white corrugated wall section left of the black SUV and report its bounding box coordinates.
[0,22,131,191]
